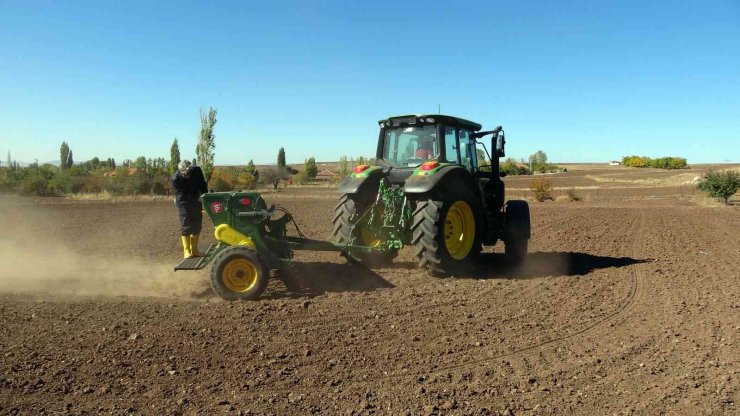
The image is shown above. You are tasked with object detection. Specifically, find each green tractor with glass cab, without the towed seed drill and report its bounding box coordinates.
[333,115,531,274]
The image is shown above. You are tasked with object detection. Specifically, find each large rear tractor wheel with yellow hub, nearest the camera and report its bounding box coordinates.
[411,190,482,274]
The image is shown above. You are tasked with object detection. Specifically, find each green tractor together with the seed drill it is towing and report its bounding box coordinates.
[175,115,530,300]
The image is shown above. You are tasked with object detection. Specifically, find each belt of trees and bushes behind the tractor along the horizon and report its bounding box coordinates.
[0,139,559,195]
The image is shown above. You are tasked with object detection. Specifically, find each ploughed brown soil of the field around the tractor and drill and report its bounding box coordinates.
[0,189,740,415]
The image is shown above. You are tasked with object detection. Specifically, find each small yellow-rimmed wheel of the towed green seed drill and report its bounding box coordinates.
[211,246,270,300]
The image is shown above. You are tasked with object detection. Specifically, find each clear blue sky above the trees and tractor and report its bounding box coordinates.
[0,0,740,164]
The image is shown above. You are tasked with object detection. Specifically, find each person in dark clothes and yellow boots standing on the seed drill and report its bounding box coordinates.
[172,160,208,259]
